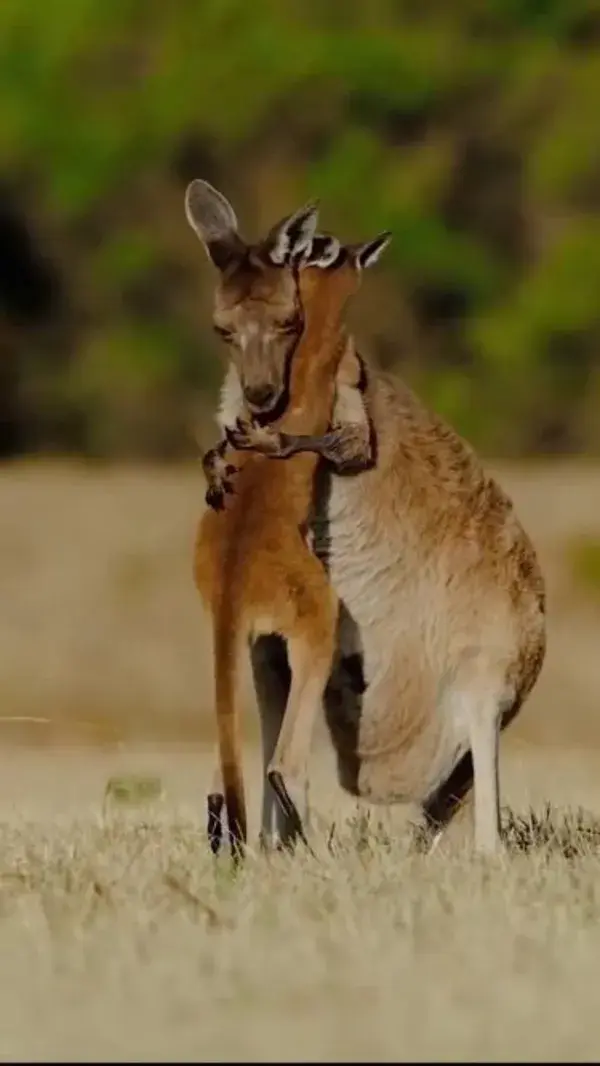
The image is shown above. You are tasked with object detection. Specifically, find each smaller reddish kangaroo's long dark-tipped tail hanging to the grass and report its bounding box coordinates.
[214,610,247,862]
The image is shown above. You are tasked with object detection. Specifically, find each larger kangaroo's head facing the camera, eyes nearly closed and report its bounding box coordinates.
[185,180,318,422]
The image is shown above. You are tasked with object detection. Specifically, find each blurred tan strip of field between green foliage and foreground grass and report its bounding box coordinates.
[0,463,600,744]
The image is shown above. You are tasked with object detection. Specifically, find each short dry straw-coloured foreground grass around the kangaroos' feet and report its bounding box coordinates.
[0,750,600,1062]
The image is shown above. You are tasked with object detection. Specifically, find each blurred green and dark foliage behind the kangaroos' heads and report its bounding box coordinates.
[0,0,600,457]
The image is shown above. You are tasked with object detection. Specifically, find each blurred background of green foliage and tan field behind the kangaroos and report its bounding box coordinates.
[0,0,600,744]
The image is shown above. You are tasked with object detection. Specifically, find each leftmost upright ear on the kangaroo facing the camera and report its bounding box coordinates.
[185,178,245,271]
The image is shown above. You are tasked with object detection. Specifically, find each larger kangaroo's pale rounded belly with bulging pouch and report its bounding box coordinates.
[315,475,518,803]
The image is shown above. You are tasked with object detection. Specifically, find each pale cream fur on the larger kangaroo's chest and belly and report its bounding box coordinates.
[314,377,526,802]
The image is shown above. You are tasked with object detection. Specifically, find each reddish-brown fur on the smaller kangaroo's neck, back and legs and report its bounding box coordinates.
[194,247,370,857]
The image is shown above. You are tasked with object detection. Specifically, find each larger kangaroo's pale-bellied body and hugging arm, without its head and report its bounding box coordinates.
[204,224,546,853]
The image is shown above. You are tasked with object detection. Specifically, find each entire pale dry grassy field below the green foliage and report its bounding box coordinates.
[0,464,600,1062]
